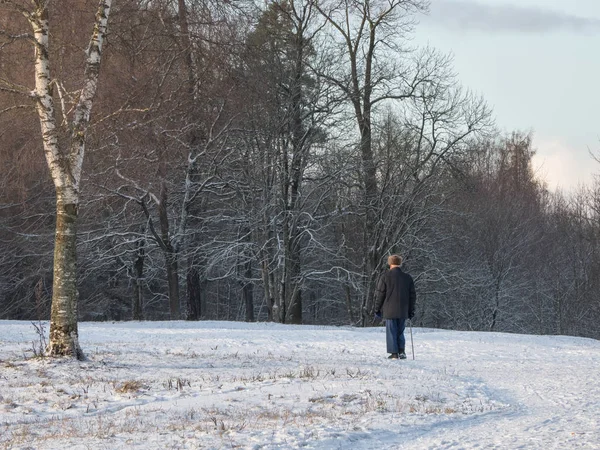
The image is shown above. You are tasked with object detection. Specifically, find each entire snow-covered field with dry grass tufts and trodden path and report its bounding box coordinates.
[0,321,600,450]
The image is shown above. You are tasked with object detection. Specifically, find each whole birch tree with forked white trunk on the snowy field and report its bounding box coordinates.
[0,0,112,359]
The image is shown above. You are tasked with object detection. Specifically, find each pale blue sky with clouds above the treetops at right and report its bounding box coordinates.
[416,0,600,192]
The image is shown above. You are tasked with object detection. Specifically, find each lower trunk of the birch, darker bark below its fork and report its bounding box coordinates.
[47,194,84,360]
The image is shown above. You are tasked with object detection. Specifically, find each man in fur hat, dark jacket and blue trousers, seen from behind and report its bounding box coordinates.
[375,255,417,359]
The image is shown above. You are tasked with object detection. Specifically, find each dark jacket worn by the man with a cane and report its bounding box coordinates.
[375,267,417,319]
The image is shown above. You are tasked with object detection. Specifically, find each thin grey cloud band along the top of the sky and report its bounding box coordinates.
[423,0,600,34]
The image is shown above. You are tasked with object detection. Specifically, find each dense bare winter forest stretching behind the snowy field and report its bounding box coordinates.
[0,0,600,339]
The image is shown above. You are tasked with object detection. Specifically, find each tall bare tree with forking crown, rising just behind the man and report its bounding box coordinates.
[316,0,444,325]
